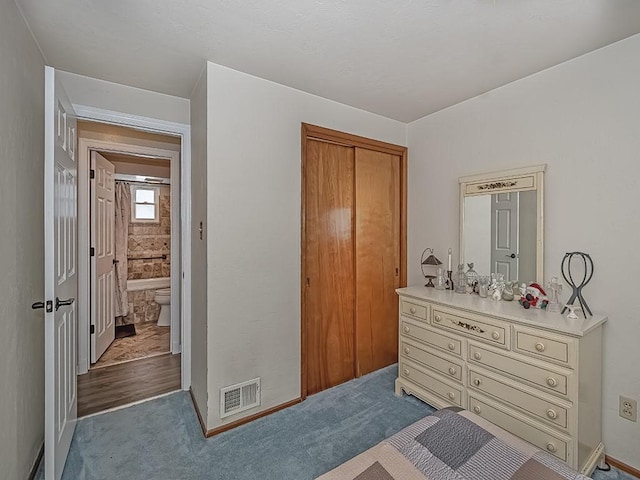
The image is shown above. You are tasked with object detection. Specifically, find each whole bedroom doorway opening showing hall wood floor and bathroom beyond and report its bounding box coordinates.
[78,121,181,416]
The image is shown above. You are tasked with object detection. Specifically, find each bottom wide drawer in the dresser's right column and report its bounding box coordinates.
[469,394,570,462]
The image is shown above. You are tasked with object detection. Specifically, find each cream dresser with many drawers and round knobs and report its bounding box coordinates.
[395,287,607,475]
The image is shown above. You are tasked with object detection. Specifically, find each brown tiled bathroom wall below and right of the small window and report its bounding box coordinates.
[127,186,171,280]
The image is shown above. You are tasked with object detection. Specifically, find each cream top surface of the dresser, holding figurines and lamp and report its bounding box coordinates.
[396,286,607,337]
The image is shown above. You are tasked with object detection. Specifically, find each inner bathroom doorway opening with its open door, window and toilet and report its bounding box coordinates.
[90,150,171,368]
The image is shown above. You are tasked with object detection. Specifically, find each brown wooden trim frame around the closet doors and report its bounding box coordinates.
[300,122,408,400]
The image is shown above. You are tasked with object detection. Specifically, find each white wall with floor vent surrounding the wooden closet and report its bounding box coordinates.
[205,63,406,428]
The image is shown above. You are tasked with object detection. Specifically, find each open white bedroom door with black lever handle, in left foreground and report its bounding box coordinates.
[44,67,78,480]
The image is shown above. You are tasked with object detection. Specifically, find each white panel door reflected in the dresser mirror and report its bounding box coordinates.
[491,192,520,280]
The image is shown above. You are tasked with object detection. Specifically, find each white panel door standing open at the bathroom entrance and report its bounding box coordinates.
[91,152,116,363]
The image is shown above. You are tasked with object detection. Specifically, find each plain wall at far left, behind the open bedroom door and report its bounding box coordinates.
[0,0,44,479]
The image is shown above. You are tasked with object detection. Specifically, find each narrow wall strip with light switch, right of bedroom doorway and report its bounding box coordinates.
[191,69,208,422]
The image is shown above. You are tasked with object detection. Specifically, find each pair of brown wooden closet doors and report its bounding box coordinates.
[302,127,406,397]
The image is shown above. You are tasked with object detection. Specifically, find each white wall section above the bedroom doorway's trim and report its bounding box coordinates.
[56,71,189,125]
